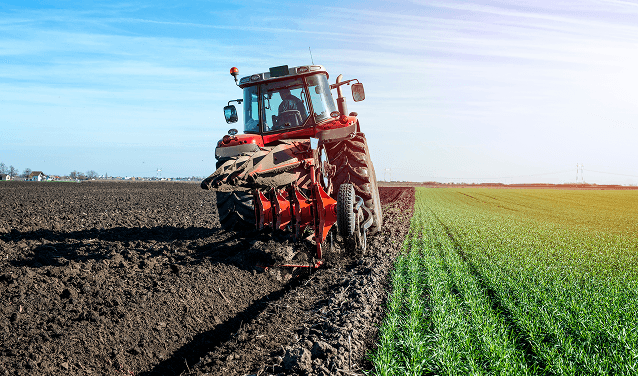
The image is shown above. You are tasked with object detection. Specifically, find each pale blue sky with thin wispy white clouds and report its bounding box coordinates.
[0,0,638,184]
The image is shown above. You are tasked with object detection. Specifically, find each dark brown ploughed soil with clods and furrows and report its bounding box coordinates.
[0,182,414,375]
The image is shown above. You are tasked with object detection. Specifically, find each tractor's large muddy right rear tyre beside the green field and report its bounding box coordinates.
[325,133,383,233]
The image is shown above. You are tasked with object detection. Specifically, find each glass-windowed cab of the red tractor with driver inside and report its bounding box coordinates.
[224,65,356,135]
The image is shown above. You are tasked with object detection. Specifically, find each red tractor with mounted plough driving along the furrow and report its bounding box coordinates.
[201,65,382,267]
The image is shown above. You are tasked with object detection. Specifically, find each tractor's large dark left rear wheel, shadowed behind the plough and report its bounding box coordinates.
[215,158,255,231]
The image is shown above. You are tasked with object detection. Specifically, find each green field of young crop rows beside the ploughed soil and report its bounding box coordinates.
[371,188,638,375]
